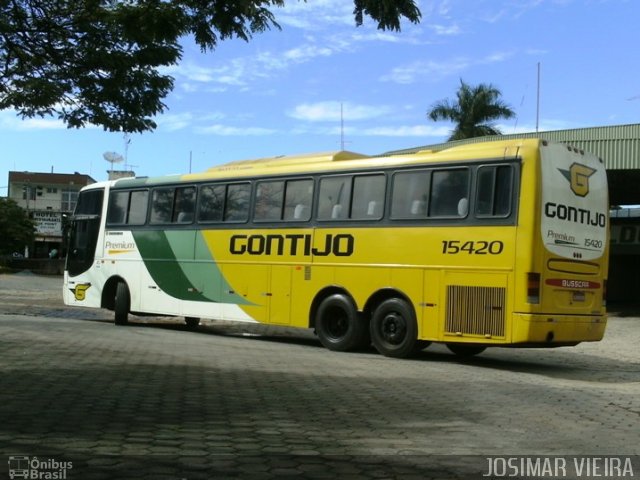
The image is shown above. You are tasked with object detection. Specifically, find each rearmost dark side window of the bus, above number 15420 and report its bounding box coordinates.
[476,165,513,217]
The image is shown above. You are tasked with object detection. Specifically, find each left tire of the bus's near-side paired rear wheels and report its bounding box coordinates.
[315,293,369,352]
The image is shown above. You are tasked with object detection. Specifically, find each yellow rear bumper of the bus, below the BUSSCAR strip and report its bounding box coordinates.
[511,313,607,347]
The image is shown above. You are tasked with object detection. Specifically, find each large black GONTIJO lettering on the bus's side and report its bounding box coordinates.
[229,233,355,257]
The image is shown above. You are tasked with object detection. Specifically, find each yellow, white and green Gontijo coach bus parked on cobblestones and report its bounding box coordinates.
[64,139,609,357]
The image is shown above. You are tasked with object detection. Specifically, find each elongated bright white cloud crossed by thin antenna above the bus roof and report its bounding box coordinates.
[287,101,393,122]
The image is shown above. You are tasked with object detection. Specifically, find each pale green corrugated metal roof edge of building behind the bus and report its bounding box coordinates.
[387,123,640,170]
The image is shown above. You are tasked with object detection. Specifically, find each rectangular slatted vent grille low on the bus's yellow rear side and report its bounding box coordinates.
[445,285,505,338]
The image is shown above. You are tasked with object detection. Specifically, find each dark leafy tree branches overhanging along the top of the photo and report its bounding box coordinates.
[0,0,421,132]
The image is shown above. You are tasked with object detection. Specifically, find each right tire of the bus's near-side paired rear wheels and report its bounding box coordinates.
[370,298,424,358]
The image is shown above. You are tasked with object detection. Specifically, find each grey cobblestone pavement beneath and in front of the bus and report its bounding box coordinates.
[0,274,640,479]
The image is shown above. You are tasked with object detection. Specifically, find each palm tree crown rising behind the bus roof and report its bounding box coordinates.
[427,79,516,141]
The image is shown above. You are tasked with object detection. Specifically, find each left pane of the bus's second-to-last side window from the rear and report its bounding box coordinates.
[391,170,429,219]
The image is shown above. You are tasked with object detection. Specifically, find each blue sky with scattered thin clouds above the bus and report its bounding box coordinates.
[0,0,640,191]
